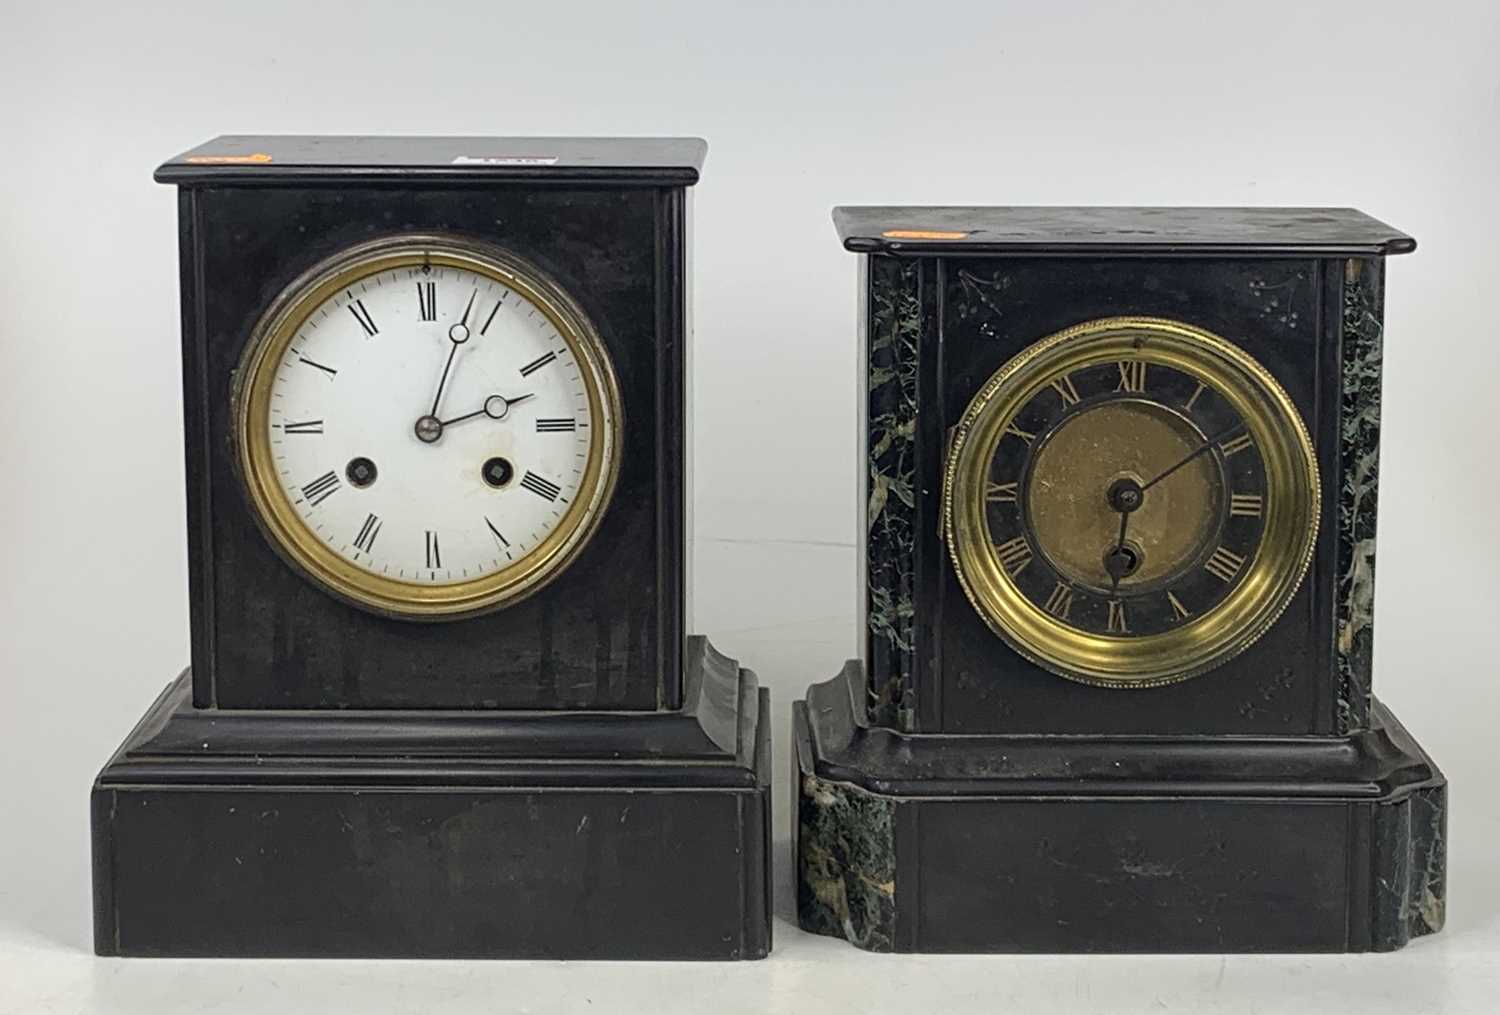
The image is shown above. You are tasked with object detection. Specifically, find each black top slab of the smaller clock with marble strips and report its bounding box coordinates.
[834,205,1416,258]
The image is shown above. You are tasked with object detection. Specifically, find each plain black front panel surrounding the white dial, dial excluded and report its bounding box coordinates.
[168,167,689,709]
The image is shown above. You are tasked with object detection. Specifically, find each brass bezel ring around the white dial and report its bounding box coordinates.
[231,234,624,621]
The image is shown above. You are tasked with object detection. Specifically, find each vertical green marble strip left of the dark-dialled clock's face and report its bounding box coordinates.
[866,256,921,729]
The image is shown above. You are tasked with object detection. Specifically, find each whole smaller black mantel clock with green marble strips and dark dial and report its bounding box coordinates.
[794,208,1446,952]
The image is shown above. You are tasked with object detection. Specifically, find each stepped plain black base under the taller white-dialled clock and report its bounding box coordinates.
[93,637,771,960]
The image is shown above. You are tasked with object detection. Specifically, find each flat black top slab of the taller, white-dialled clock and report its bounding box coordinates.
[156,135,708,187]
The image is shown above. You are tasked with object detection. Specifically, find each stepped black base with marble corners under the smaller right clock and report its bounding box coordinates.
[794,663,1446,952]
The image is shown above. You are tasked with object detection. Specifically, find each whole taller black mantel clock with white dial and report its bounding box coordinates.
[93,136,771,958]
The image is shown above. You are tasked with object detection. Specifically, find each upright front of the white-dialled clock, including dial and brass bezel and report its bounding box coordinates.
[182,184,686,709]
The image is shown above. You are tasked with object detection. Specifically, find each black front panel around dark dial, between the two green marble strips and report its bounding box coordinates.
[924,253,1346,735]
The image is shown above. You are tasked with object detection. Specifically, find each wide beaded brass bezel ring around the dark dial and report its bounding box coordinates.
[942,316,1322,688]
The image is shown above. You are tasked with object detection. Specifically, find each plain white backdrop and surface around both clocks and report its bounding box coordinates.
[0,0,1500,1014]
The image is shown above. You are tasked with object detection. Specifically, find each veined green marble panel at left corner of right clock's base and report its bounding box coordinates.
[797,772,896,952]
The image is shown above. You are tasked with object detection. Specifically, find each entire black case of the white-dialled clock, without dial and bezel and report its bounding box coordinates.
[92,136,771,958]
